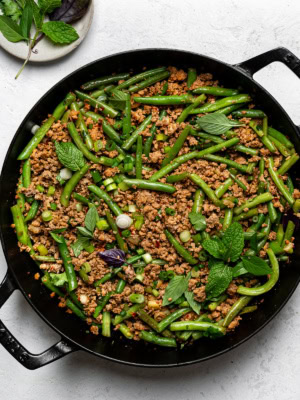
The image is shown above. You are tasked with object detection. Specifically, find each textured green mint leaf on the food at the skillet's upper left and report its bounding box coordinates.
[55,142,84,171]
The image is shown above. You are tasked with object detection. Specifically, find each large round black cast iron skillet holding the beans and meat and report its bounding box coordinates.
[0,48,300,369]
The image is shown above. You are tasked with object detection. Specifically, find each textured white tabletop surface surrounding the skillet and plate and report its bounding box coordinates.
[0,0,300,400]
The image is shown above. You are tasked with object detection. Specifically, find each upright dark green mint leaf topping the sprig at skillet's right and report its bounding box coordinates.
[222,222,244,262]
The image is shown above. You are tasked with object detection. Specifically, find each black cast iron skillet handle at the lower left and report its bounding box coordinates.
[0,272,78,370]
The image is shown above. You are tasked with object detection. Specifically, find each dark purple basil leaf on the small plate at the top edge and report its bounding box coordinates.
[49,0,90,24]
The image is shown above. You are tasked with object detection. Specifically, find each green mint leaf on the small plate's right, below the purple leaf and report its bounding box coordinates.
[42,21,79,44]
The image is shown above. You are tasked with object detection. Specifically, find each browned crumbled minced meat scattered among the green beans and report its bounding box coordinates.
[12,67,300,340]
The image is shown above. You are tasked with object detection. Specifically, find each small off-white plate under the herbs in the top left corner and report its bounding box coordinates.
[0,0,94,62]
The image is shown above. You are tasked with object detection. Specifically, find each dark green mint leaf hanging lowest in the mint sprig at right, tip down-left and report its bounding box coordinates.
[205,263,232,300]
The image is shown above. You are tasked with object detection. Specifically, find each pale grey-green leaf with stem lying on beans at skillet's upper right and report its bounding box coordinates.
[197,114,243,135]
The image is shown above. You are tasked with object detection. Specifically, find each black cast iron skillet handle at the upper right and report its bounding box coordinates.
[234,47,300,78]
